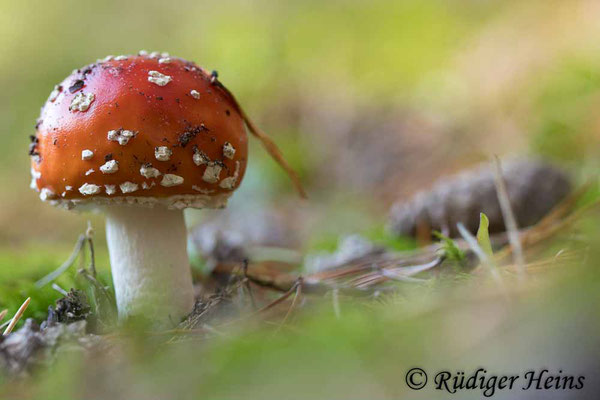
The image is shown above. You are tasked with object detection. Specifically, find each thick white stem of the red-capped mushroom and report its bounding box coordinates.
[105,205,194,325]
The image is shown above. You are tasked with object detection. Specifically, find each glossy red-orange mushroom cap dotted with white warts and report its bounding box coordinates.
[30,53,248,208]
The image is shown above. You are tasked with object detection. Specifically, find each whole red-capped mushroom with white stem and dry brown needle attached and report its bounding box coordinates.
[30,52,300,322]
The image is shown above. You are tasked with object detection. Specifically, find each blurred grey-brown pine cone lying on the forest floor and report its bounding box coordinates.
[388,159,571,241]
